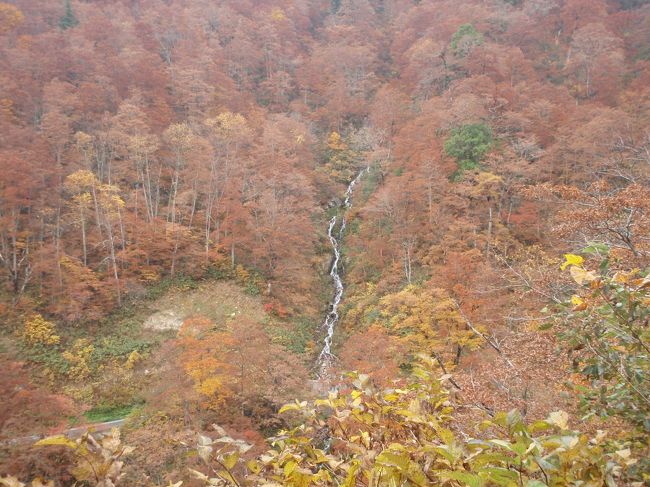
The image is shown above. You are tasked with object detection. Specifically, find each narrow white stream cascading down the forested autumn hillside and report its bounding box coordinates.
[317,167,370,379]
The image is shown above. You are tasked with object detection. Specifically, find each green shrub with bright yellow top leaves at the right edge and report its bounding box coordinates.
[555,250,650,435]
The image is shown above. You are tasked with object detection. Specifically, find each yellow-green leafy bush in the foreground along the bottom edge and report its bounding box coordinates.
[193,356,640,487]
